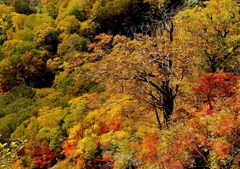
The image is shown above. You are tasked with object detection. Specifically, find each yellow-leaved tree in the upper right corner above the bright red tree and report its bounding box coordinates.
[176,0,240,73]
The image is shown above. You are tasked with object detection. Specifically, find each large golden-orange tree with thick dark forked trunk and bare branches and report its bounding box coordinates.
[90,31,189,128]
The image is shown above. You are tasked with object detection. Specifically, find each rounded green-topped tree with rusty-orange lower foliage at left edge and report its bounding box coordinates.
[0,37,53,89]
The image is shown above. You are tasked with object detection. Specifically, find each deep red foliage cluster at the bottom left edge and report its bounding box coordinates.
[31,147,54,168]
